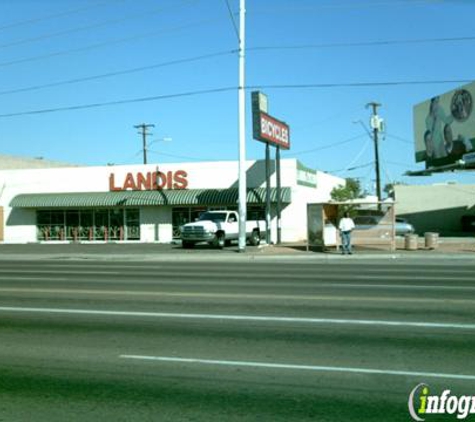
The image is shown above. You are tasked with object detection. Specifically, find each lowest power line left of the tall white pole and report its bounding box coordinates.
[0,87,238,118]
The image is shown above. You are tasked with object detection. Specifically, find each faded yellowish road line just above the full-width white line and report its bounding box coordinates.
[0,287,475,305]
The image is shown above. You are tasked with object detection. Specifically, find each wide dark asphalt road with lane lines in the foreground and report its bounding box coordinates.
[0,259,475,422]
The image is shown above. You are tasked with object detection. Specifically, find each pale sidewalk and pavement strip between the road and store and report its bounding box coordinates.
[0,237,475,263]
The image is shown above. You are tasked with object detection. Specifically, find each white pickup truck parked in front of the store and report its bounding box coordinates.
[181,211,265,248]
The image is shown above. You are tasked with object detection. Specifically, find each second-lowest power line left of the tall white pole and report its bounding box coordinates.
[0,50,238,95]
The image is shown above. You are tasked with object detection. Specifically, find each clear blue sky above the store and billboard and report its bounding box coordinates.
[0,0,475,192]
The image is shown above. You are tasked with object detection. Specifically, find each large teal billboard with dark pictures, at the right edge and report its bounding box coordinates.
[414,82,475,168]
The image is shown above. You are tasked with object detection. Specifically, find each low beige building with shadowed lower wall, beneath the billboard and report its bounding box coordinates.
[394,183,475,235]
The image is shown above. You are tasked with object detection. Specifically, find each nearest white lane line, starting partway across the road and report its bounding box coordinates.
[119,355,475,381]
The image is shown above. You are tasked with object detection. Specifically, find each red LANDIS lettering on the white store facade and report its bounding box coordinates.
[109,170,188,191]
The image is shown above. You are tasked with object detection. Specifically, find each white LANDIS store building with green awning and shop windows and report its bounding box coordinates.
[0,159,344,243]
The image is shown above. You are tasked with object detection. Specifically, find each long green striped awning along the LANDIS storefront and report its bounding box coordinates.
[10,187,291,208]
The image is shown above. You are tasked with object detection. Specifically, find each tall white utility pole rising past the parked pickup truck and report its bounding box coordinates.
[238,0,247,252]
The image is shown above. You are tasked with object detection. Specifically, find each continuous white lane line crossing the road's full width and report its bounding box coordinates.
[0,306,475,330]
